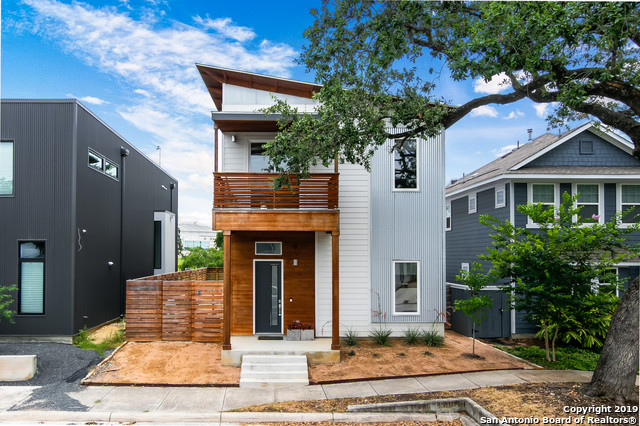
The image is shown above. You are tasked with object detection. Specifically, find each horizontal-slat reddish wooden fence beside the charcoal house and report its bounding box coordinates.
[126,268,224,342]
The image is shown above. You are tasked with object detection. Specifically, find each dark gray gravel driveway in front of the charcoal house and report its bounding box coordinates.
[0,343,102,411]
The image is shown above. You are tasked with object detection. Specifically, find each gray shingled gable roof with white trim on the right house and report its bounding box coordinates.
[446,123,639,195]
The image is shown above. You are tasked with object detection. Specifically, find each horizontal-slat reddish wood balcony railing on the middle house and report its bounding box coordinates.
[213,173,338,210]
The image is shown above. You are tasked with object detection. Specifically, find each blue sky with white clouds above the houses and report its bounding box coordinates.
[0,0,580,225]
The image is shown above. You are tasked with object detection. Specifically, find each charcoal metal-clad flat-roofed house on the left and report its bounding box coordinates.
[0,99,178,338]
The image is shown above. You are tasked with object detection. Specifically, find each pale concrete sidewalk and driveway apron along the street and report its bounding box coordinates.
[0,370,591,424]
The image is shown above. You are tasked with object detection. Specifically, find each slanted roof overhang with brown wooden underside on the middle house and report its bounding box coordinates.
[196,64,322,111]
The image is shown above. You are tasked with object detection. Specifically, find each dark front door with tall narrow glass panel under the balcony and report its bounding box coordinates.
[253,260,282,334]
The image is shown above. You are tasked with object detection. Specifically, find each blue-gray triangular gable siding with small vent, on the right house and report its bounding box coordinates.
[526,131,638,168]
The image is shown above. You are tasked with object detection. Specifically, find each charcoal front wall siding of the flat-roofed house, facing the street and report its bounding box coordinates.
[0,101,76,335]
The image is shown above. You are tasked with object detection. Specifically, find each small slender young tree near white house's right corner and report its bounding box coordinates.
[454,262,493,355]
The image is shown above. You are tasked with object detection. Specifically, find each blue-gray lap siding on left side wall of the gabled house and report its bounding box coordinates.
[446,183,511,283]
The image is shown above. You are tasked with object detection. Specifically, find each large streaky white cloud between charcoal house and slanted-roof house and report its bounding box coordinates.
[19,0,298,225]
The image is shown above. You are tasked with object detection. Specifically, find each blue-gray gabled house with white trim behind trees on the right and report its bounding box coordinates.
[446,123,640,337]
